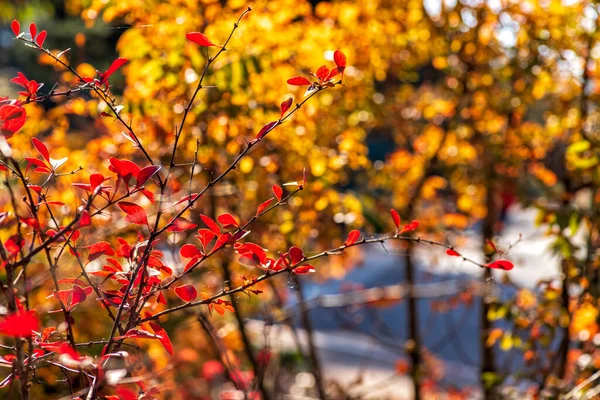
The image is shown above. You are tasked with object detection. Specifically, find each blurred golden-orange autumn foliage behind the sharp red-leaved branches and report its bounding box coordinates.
[0,0,600,397]
